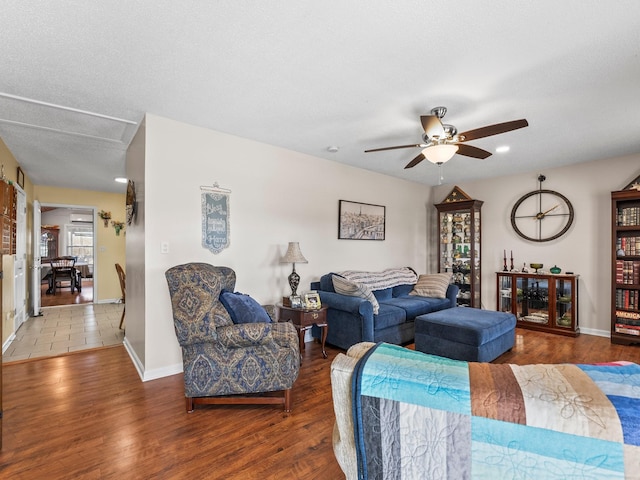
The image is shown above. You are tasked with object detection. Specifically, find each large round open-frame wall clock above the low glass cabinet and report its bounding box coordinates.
[511,175,573,242]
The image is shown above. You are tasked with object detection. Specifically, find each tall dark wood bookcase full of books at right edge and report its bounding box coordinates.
[611,184,640,345]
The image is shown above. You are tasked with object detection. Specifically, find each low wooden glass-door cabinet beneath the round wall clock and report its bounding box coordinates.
[497,272,580,337]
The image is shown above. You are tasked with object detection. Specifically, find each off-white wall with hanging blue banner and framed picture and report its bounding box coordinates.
[134,115,433,379]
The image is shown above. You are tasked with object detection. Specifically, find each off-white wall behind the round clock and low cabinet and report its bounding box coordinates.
[430,155,640,336]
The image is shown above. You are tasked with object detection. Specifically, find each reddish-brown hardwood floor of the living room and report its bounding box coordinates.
[0,329,640,480]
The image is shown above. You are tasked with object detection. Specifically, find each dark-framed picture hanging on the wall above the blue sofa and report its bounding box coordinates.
[338,200,386,241]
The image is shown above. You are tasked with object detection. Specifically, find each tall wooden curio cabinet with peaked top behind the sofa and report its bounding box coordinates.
[435,187,484,308]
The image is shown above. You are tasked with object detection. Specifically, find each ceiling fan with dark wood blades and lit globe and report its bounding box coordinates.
[365,107,529,168]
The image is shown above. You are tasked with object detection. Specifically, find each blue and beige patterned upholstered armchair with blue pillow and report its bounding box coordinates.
[165,263,300,412]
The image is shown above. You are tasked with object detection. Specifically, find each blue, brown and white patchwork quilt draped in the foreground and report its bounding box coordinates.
[352,343,640,480]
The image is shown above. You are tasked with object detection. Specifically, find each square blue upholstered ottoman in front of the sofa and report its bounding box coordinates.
[415,307,516,362]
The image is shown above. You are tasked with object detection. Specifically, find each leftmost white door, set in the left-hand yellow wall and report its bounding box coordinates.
[13,188,27,332]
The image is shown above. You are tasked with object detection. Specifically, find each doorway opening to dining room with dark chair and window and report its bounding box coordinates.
[34,204,96,307]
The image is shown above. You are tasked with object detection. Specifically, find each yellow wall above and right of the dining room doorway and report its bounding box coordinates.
[30,185,126,302]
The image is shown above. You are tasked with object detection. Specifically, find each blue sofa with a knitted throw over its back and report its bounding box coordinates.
[311,273,458,350]
